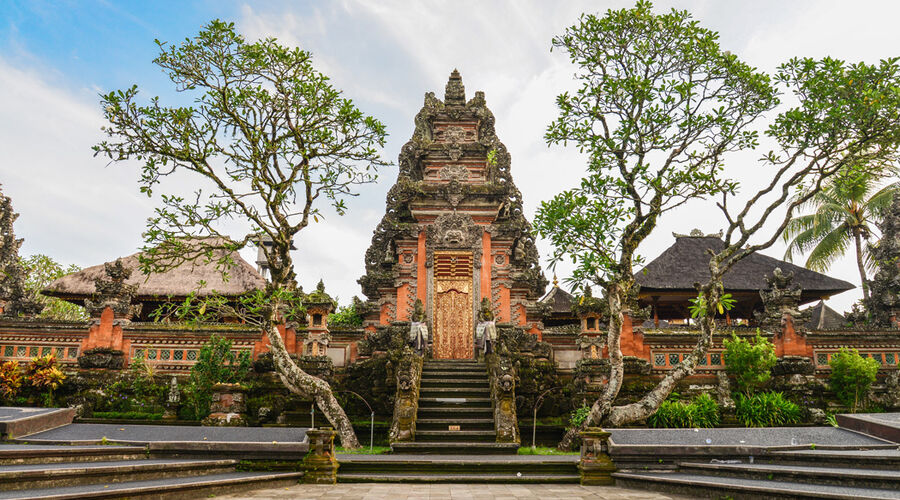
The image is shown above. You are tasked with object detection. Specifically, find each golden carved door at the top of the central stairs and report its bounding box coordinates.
[433,252,475,359]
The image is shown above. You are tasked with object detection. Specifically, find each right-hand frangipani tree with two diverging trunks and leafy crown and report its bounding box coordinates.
[535,1,900,446]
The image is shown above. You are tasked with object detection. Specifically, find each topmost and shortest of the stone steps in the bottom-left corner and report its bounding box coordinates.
[0,444,147,465]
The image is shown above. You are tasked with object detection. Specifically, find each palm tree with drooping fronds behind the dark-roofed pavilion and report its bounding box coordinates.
[782,167,900,299]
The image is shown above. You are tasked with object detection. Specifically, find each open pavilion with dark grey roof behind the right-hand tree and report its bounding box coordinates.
[635,233,854,319]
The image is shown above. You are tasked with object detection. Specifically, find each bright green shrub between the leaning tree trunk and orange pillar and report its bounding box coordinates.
[722,330,777,396]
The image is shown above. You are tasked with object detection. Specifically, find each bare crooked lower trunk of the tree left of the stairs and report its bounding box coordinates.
[266,322,360,449]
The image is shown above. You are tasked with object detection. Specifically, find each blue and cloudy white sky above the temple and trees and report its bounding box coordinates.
[0,0,900,311]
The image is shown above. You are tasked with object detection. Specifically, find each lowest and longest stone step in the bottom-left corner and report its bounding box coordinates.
[0,472,303,500]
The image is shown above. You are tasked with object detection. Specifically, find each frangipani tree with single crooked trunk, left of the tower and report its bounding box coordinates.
[94,21,388,448]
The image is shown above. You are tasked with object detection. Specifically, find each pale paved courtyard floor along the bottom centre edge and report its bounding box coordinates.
[216,483,687,500]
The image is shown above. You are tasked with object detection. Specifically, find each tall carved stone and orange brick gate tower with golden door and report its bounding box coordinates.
[359,70,547,359]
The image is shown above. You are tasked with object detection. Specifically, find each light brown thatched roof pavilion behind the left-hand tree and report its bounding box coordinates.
[42,242,266,320]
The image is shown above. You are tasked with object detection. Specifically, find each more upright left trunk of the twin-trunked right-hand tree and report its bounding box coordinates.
[559,284,625,450]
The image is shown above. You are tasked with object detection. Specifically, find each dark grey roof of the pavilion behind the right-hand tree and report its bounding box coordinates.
[635,236,854,295]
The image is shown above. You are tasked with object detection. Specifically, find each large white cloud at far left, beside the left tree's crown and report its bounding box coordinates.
[0,58,149,266]
